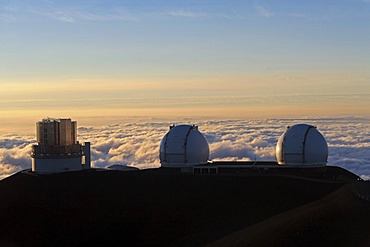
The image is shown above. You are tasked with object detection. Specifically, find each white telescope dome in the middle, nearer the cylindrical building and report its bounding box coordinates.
[159,125,209,167]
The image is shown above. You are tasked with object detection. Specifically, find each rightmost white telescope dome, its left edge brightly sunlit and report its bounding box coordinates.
[276,124,328,166]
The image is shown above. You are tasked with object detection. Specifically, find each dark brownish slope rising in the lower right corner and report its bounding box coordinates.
[208,184,370,247]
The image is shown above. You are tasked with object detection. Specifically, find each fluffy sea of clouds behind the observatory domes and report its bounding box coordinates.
[0,118,370,179]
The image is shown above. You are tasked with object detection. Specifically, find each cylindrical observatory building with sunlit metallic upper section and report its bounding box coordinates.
[31,118,90,173]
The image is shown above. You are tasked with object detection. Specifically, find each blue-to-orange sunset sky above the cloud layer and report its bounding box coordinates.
[0,0,370,131]
